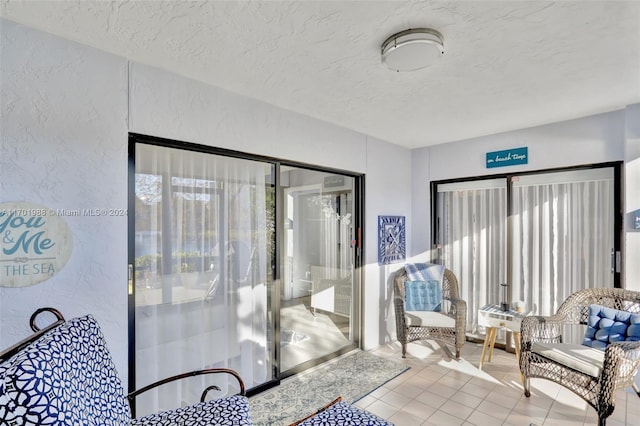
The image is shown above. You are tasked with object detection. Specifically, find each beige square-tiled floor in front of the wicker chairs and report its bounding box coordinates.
[362,341,640,426]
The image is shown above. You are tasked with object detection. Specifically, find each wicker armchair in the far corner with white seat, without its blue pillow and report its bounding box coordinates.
[394,268,467,359]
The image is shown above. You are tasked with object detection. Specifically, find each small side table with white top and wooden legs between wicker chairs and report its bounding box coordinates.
[478,304,527,370]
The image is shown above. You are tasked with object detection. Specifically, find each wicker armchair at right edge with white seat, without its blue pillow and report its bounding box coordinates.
[520,288,640,425]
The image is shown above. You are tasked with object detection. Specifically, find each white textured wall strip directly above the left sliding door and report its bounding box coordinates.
[130,64,366,173]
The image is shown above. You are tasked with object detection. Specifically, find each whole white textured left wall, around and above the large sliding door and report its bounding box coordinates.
[0,20,411,379]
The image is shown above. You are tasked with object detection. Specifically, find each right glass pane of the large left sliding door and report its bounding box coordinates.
[280,167,358,374]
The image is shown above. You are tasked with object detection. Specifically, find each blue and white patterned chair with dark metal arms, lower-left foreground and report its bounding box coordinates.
[0,315,251,426]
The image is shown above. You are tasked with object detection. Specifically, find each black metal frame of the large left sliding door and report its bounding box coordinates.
[127,133,365,402]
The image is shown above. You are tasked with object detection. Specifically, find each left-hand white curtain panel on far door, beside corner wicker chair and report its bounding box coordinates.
[438,179,507,332]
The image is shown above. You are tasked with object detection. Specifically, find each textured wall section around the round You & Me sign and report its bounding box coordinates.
[0,21,127,377]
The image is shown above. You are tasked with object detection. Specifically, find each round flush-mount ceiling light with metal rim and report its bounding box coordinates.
[381,28,444,71]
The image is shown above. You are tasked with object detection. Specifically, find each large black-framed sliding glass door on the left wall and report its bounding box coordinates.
[129,135,362,415]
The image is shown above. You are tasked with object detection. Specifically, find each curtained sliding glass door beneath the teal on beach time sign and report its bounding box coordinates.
[434,167,620,340]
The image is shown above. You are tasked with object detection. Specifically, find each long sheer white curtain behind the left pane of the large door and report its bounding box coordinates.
[135,143,273,415]
